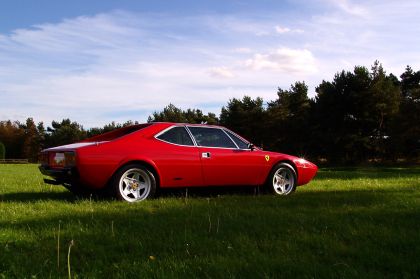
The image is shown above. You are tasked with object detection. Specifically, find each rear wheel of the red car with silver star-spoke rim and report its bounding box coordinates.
[110,164,156,202]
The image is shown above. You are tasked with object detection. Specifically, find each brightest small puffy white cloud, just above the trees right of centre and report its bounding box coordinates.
[245,48,317,74]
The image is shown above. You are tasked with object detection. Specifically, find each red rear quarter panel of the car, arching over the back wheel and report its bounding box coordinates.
[78,125,203,188]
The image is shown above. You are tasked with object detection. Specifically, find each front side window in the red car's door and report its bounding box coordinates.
[188,127,236,148]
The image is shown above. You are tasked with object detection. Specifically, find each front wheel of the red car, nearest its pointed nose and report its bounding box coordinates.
[267,163,297,196]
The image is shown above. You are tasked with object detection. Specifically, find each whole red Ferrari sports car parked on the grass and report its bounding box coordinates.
[39,123,318,202]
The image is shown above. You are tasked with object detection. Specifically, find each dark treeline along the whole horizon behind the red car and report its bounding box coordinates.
[0,61,420,164]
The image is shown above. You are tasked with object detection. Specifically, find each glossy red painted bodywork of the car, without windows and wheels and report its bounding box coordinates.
[41,123,318,189]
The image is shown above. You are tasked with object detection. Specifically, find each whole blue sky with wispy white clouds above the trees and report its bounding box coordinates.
[0,0,420,128]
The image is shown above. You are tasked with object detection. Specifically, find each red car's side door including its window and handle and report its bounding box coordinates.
[188,126,264,186]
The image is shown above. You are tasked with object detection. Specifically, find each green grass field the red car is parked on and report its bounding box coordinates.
[0,165,420,278]
